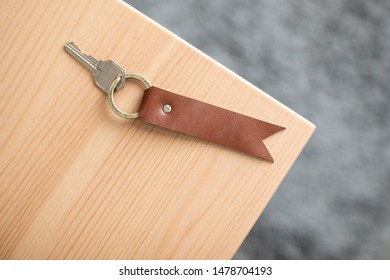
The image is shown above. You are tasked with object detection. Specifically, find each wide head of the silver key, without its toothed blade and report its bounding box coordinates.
[93,60,126,93]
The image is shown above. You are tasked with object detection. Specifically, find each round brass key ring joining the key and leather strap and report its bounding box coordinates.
[108,73,152,119]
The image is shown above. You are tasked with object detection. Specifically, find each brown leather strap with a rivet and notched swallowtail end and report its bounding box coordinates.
[139,87,285,162]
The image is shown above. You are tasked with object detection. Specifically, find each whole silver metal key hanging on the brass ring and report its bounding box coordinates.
[65,42,125,93]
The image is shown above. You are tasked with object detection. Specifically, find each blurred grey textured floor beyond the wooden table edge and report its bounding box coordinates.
[127,0,390,259]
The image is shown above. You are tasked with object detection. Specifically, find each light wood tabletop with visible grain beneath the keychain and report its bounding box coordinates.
[0,0,314,259]
